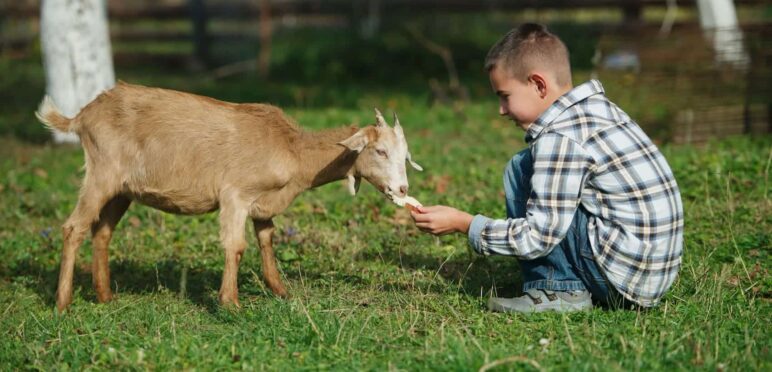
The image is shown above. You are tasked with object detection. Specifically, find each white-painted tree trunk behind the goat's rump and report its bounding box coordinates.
[40,0,115,143]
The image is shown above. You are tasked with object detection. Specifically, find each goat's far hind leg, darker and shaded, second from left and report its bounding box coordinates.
[91,196,131,302]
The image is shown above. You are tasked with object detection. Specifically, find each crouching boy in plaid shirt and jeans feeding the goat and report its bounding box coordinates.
[412,24,683,312]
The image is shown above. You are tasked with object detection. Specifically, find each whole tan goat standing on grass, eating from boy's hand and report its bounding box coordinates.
[36,82,420,311]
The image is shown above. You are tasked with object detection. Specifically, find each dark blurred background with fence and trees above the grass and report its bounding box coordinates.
[0,0,772,144]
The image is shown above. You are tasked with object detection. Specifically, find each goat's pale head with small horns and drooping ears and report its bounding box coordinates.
[340,109,423,198]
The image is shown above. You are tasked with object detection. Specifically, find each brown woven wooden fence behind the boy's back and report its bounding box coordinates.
[597,23,772,144]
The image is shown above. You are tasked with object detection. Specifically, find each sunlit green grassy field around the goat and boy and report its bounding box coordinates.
[0,20,772,371]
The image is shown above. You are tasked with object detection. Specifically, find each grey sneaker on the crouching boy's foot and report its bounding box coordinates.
[488,289,592,313]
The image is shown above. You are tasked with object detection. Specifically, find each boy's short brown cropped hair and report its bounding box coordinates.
[485,23,571,86]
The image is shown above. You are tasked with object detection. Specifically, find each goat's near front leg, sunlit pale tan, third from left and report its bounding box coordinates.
[219,205,247,307]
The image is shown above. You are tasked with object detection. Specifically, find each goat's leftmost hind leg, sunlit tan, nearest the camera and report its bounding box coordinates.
[56,186,109,312]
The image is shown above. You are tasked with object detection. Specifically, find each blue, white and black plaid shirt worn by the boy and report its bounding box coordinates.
[469,80,683,306]
